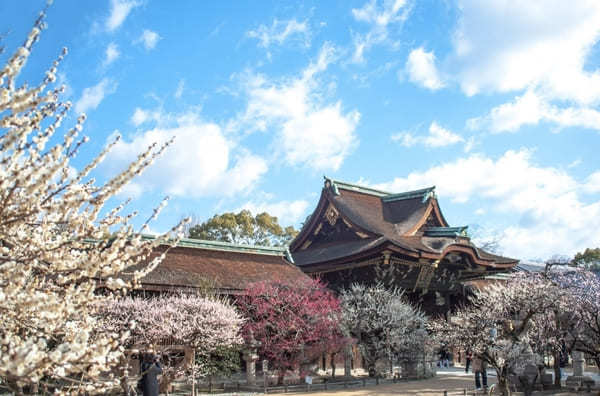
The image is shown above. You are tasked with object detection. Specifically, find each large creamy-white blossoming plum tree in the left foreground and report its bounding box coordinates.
[0,12,185,394]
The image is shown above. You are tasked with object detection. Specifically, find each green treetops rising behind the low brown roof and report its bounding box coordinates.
[188,210,298,246]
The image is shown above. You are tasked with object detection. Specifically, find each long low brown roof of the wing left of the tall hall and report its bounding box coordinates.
[141,240,307,292]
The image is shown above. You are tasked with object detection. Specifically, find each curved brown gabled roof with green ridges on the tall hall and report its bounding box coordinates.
[290,179,517,266]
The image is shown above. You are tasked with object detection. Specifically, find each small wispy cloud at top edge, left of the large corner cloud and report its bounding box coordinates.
[352,0,410,63]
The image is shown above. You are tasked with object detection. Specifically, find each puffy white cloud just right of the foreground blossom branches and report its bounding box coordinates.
[103,114,267,197]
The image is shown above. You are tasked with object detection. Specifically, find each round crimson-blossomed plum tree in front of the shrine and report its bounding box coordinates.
[237,279,347,381]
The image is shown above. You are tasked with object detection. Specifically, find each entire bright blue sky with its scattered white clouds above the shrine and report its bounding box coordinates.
[0,0,600,259]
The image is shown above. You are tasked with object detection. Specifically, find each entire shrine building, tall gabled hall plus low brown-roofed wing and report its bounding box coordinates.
[141,178,518,315]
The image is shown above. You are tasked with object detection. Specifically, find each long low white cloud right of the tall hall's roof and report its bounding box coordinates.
[376,149,600,258]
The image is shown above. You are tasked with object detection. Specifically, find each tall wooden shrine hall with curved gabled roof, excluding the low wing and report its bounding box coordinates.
[289,178,518,314]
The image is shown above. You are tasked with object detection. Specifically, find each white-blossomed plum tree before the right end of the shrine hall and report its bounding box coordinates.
[430,273,569,395]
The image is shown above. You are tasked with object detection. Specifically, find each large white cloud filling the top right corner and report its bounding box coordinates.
[454,0,600,103]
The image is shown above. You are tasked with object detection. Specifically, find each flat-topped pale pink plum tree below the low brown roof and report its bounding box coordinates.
[98,295,243,389]
